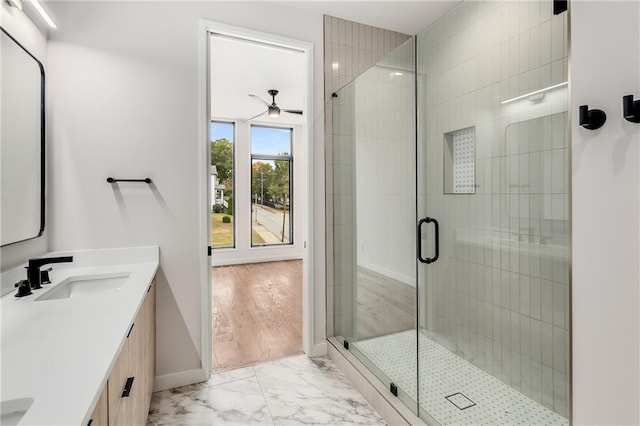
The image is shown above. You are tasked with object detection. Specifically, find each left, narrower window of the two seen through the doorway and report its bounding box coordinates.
[211,121,235,249]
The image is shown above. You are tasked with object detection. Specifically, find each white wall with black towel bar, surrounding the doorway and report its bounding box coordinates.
[49,2,325,376]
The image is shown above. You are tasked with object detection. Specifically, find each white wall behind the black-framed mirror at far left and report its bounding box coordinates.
[0,2,49,271]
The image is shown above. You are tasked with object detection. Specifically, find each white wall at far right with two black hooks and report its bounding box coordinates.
[571,1,640,425]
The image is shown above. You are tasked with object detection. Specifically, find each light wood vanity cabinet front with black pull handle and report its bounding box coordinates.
[90,280,156,426]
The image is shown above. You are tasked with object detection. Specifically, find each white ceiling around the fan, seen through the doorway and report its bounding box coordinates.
[211,35,307,125]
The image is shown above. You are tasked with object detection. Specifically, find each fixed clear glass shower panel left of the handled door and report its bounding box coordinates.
[331,40,417,411]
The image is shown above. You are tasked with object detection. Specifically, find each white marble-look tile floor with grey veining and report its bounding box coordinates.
[147,355,385,425]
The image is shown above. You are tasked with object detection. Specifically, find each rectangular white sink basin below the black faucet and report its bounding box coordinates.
[35,272,131,301]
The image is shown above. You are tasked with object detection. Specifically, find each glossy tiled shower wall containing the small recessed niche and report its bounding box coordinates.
[418,1,569,417]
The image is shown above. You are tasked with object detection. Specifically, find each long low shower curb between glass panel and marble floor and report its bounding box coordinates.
[327,337,438,426]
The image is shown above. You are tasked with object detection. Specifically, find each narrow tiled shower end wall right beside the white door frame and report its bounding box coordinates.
[324,15,409,336]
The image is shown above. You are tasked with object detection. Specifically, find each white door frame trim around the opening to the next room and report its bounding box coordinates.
[198,19,314,375]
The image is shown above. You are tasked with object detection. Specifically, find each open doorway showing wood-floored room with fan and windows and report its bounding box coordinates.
[203,23,312,371]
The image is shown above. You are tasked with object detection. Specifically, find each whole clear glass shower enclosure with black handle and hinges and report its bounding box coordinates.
[331,0,570,424]
